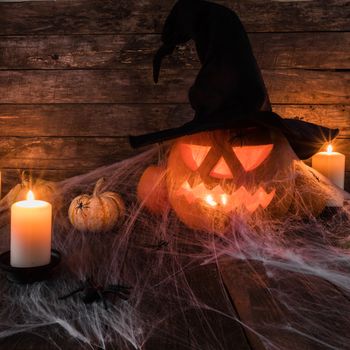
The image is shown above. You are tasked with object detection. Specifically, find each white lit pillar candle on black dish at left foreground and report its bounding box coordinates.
[11,191,52,267]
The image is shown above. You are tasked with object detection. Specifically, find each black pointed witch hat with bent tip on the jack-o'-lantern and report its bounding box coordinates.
[129,0,339,159]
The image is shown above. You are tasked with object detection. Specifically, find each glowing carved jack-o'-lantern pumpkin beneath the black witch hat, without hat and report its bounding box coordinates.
[167,128,295,233]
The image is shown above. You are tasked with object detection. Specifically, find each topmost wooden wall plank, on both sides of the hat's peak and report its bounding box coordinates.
[0,0,350,35]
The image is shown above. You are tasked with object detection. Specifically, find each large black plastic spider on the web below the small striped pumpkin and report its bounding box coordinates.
[59,278,131,310]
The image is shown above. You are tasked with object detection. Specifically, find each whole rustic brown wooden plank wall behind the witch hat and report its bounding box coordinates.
[0,0,350,194]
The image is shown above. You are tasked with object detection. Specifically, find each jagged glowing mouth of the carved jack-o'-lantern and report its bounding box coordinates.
[178,181,276,213]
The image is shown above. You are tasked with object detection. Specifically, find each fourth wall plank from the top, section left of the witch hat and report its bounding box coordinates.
[0,104,193,137]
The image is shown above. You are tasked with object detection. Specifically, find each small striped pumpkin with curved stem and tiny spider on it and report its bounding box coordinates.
[68,179,125,232]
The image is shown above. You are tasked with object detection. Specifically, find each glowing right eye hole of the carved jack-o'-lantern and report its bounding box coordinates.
[233,144,273,171]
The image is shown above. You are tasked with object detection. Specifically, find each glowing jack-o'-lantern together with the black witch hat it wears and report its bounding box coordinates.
[129,1,339,233]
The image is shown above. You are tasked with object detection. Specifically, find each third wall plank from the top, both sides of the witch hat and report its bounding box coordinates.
[0,69,350,104]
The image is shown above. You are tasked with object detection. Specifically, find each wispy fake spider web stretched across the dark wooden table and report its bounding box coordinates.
[0,141,350,350]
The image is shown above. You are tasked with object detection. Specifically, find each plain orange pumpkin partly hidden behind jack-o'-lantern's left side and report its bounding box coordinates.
[137,165,168,214]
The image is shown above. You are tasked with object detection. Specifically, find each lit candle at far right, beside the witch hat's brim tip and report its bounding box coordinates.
[312,145,345,188]
